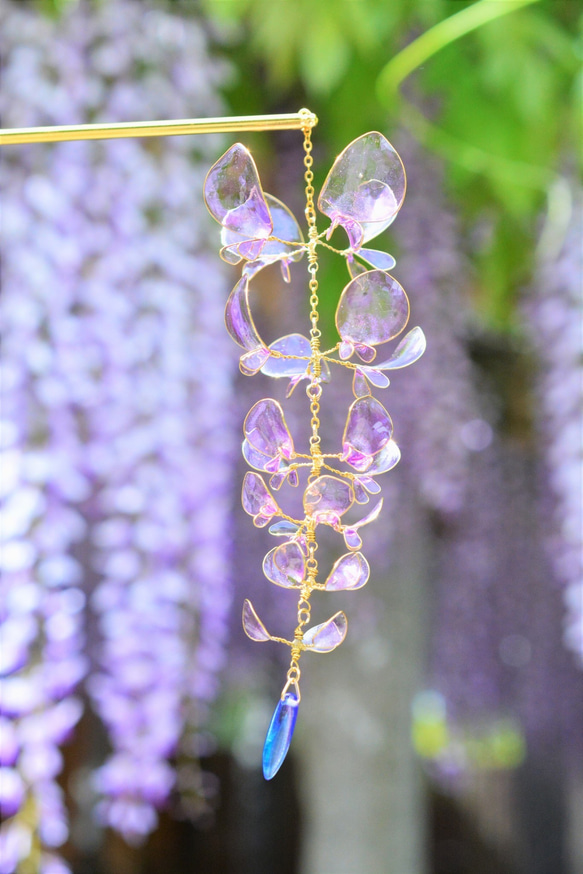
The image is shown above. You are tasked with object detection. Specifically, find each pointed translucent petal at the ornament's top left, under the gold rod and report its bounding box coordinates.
[204,143,273,240]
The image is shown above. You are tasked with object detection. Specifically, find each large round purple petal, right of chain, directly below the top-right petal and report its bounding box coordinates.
[336,270,409,346]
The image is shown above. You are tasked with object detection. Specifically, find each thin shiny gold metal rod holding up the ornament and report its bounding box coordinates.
[0,109,318,146]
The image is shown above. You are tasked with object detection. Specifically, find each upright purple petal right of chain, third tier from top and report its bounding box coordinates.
[342,396,393,472]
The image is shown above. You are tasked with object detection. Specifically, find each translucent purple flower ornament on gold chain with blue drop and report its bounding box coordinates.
[204,110,425,780]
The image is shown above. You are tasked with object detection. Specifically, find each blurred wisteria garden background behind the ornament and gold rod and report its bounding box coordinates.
[0,0,583,874]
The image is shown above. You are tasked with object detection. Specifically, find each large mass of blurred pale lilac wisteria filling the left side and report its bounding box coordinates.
[0,0,233,874]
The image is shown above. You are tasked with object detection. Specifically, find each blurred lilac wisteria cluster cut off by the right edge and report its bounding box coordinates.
[524,198,583,665]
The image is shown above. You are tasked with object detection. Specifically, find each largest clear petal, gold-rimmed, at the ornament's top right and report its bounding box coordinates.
[318,131,406,248]
